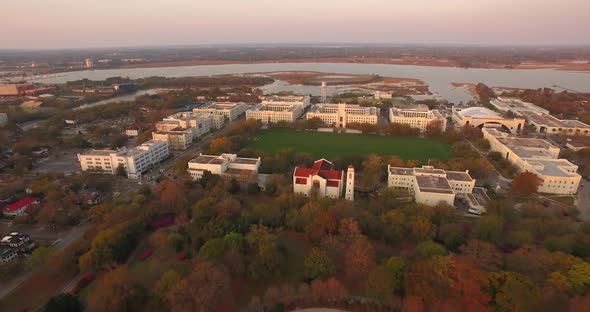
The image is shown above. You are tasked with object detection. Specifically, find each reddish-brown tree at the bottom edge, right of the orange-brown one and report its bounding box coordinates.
[168,262,232,312]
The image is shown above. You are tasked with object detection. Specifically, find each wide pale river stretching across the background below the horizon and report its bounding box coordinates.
[34,63,590,102]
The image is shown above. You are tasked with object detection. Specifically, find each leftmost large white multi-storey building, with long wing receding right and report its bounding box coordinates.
[78,140,169,179]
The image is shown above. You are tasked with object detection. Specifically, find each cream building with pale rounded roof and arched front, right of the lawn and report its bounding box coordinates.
[453,107,525,133]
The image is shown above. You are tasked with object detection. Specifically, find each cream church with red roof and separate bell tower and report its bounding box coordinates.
[293,159,354,200]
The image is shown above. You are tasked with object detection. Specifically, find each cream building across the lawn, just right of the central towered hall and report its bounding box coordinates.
[389,105,447,132]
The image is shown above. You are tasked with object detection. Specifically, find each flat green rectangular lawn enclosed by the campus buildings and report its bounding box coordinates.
[247,129,453,164]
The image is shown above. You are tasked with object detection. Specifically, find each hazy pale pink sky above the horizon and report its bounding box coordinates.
[0,0,590,49]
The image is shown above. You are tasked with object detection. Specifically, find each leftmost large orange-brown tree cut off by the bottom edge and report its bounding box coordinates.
[88,266,143,312]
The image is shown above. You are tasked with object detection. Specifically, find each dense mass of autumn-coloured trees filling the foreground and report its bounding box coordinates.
[39,168,590,311]
